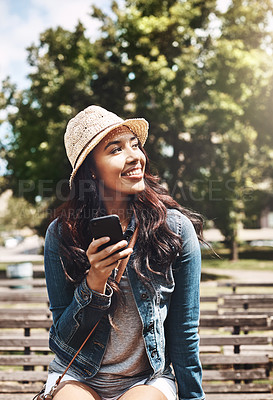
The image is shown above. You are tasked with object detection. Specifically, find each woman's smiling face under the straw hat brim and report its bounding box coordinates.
[93,126,146,200]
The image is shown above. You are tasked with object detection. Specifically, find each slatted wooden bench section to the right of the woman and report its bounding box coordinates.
[200,314,273,400]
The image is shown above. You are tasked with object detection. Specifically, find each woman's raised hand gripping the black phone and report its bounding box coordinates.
[86,236,133,293]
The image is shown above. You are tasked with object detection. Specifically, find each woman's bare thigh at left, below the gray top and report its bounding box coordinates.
[54,381,101,400]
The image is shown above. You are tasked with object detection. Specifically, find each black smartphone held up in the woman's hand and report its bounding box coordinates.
[90,214,123,251]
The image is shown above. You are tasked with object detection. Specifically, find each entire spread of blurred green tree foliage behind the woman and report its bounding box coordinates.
[1,0,273,255]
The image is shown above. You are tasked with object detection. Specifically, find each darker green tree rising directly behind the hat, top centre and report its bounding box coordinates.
[92,0,216,181]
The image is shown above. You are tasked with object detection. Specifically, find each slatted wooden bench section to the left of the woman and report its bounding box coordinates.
[0,310,53,400]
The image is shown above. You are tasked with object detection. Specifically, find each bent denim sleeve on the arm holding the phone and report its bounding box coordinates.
[44,220,113,344]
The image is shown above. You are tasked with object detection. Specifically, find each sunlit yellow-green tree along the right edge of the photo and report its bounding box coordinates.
[189,0,273,259]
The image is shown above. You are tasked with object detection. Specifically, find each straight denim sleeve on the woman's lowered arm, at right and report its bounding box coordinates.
[166,212,205,400]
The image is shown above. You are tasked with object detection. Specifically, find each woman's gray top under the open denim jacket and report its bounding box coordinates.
[50,271,159,397]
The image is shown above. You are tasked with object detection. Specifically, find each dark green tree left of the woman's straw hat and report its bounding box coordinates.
[1,23,96,202]
